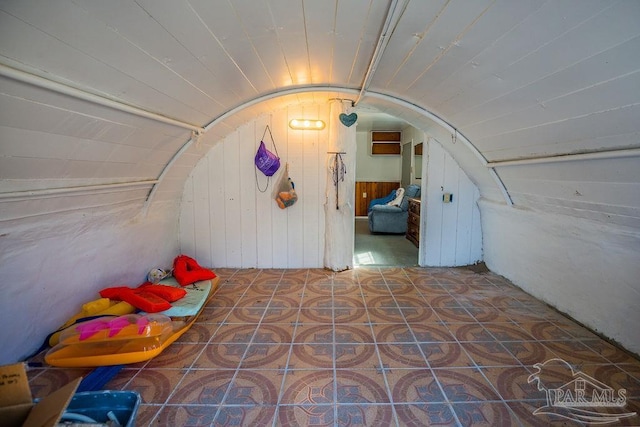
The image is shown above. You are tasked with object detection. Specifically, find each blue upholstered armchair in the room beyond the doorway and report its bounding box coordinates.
[369,184,420,234]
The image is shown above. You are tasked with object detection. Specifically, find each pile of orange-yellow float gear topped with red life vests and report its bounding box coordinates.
[45,255,218,367]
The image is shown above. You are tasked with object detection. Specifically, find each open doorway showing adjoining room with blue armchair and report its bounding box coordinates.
[353,112,423,267]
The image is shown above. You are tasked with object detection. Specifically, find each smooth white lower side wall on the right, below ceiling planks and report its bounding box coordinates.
[479,199,640,354]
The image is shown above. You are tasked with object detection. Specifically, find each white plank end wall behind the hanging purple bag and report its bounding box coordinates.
[180,105,330,268]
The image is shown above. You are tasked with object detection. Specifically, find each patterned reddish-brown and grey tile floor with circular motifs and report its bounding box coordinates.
[29,268,640,427]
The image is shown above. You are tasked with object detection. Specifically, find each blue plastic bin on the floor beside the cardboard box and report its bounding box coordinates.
[63,390,141,427]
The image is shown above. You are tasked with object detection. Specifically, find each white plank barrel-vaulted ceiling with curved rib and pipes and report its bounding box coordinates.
[0,0,640,227]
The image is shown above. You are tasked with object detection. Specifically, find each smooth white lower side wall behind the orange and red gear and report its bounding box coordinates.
[0,205,178,365]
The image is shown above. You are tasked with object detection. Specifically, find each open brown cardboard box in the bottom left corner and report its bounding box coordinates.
[0,363,82,427]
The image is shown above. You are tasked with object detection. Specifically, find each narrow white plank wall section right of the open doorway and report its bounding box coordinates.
[419,137,482,267]
